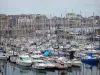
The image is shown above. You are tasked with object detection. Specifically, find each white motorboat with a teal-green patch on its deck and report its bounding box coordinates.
[16,54,32,66]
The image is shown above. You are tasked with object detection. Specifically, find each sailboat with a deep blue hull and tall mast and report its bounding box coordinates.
[81,14,98,65]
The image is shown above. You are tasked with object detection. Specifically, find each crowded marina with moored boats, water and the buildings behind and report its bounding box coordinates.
[0,14,100,75]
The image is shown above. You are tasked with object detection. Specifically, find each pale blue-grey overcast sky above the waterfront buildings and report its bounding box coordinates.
[0,0,100,16]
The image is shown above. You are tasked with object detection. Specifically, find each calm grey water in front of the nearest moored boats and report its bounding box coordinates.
[0,61,100,75]
